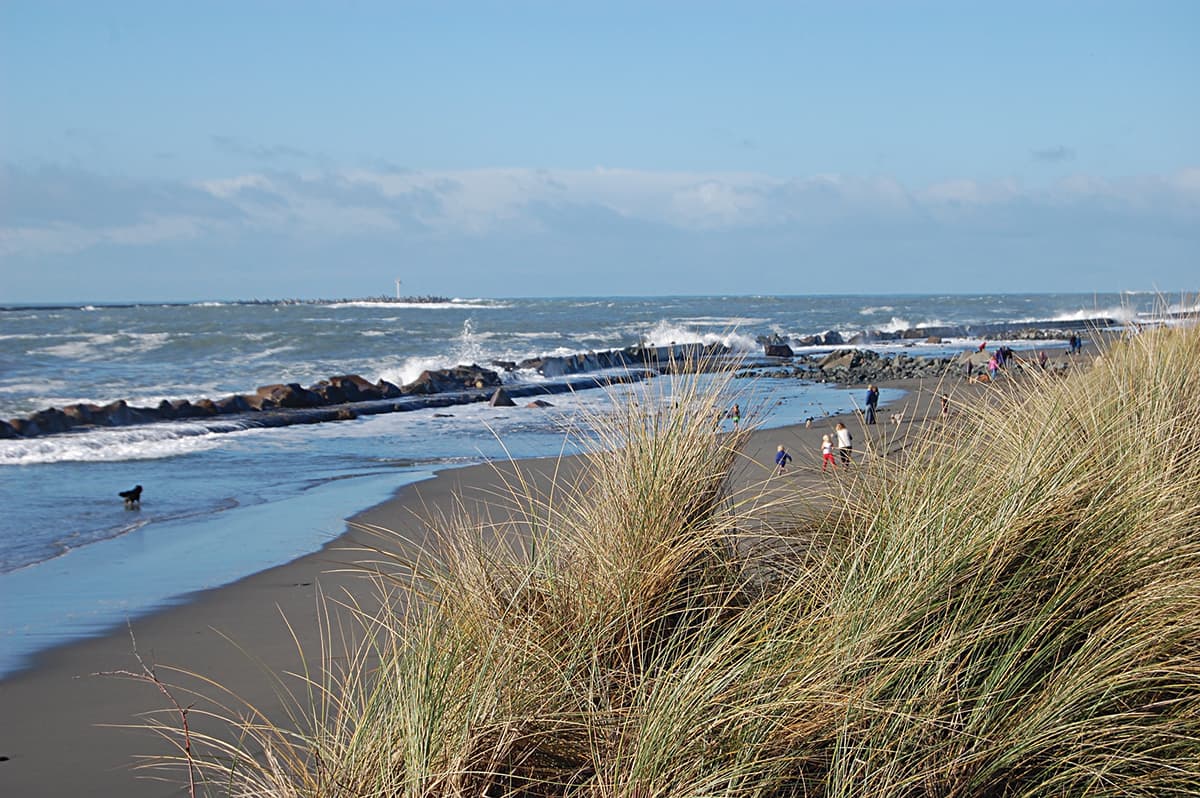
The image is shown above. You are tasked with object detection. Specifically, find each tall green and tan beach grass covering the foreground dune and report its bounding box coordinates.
[145,329,1200,798]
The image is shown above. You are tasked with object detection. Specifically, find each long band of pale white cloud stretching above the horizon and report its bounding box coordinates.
[0,167,1200,257]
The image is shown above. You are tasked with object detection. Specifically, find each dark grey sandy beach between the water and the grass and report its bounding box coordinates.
[0,380,986,798]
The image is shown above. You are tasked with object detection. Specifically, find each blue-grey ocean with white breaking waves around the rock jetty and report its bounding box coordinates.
[0,293,1180,676]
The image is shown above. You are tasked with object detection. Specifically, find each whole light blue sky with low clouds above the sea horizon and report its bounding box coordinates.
[0,0,1200,304]
